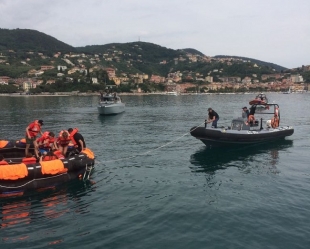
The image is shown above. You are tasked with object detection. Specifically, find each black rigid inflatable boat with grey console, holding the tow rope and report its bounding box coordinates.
[190,104,294,146]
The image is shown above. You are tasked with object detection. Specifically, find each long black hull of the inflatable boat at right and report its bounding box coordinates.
[190,126,294,146]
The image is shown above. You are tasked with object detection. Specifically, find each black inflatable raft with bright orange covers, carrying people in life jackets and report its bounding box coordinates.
[0,147,95,195]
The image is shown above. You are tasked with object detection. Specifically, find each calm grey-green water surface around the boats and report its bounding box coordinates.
[0,93,310,249]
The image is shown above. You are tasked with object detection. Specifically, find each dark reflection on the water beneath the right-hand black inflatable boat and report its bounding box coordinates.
[190,140,293,174]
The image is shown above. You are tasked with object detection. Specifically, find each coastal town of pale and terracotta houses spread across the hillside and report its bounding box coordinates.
[0,45,310,94]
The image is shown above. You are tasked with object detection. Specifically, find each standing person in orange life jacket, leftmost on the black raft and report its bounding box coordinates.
[25,119,43,157]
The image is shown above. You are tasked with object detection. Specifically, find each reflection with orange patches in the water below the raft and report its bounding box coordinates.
[0,181,95,233]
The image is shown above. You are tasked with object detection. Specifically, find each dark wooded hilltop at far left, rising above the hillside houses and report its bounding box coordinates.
[0,29,75,53]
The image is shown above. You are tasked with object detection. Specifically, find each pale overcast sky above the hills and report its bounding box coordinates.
[0,0,310,68]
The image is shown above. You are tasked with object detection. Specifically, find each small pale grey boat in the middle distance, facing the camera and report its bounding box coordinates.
[97,95,125,115]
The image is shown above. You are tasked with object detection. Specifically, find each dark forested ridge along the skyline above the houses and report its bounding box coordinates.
[0,28,287,71]
